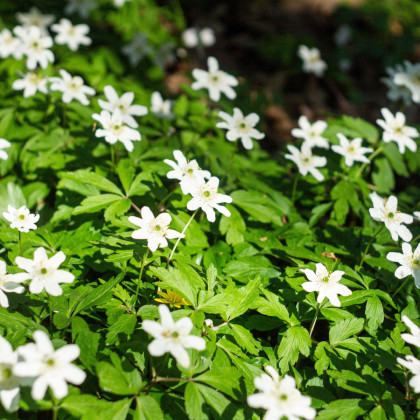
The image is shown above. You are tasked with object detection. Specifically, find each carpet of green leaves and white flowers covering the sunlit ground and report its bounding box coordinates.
[0,0,420,420]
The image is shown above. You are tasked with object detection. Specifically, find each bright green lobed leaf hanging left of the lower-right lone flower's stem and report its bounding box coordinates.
[277,326,311,373]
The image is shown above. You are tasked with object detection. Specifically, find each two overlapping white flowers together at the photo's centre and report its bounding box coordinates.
[164,150,232,222]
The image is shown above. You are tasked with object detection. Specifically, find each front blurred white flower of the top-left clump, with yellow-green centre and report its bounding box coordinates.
[13,26,54,70]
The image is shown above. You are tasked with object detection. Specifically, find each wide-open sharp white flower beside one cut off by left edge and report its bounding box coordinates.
[13,247,74,296]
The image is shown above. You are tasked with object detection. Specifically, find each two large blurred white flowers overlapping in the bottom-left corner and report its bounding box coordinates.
[0,330,86,412]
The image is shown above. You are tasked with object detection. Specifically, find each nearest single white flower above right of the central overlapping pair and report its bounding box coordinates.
[216,108,265,150]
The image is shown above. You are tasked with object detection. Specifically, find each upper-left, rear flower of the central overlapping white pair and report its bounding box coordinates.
[164,150,211,194]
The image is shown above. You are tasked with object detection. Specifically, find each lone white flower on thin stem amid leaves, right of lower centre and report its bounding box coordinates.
[300,263,351,306]
